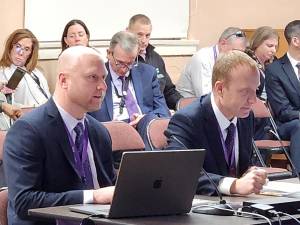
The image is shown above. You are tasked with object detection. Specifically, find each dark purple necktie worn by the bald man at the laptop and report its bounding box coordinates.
[74,122,94,189]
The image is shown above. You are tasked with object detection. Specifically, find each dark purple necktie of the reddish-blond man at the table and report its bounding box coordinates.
[225,123,236,177]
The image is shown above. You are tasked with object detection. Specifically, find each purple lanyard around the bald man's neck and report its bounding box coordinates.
[65,121,88,183]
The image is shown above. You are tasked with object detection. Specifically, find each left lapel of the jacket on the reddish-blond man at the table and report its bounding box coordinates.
[203,95,228,175]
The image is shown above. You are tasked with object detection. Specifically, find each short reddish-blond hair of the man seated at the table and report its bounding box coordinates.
[212,50,257,87]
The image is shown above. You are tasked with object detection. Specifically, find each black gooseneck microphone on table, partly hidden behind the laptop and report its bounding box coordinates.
[164,130,234,216]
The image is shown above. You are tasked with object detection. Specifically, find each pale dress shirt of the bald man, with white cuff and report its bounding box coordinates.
[53,98,100,203]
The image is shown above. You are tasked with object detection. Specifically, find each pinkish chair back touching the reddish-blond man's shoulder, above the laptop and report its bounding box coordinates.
[147,118,170,150]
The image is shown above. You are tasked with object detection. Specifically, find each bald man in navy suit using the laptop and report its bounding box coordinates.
[4,46,115,225]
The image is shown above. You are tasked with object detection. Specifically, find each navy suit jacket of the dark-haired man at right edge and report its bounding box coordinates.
[266,55,300,123]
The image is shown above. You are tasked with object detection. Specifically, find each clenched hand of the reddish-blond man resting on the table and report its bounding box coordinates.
[230,167,267,195]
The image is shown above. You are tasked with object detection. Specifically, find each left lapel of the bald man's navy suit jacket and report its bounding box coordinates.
[47,98,80,178]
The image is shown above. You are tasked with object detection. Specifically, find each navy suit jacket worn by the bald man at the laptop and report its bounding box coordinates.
[4,99,115,225]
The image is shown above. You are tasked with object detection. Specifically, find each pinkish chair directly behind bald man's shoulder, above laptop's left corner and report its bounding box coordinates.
[102,121,145,169]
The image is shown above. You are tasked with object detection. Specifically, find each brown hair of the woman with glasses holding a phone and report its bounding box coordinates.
[0,29,39,72]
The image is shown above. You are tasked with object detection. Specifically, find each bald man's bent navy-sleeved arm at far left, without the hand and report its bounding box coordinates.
[3,119,83,218]
